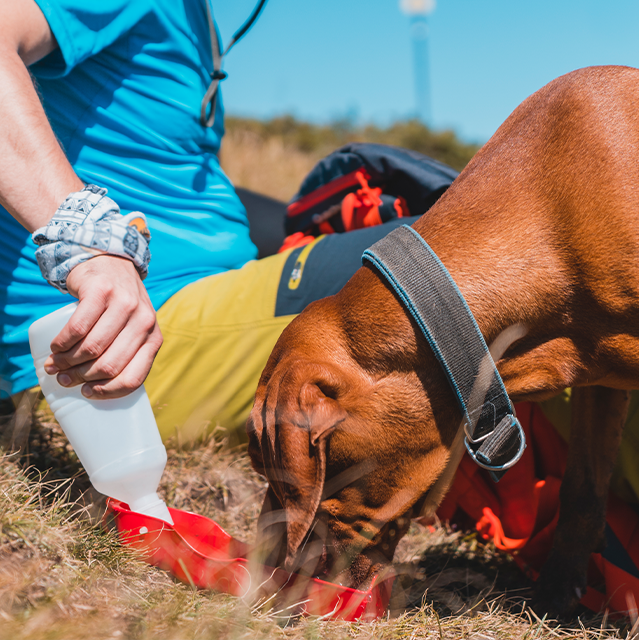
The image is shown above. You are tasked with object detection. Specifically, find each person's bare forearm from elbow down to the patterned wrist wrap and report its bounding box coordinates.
[0,43,83,231]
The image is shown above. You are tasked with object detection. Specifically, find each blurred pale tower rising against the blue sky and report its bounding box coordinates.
[399,0,435,126]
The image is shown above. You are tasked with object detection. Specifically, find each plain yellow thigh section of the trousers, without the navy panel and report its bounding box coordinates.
[145,252,295,442]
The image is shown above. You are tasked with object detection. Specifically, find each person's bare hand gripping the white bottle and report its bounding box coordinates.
[44,254,162,399]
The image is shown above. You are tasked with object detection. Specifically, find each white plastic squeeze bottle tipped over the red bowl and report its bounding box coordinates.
[29,302,173,524]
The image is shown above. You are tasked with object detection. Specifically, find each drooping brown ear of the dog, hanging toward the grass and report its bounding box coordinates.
[263,382,346,570]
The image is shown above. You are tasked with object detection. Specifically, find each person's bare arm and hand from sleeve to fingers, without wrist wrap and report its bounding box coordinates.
[0,0,162,398]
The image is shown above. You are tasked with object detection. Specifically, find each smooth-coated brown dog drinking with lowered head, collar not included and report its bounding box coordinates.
[247,67,639,615]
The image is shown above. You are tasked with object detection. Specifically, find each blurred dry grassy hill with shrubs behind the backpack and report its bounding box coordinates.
[221,116,479,201]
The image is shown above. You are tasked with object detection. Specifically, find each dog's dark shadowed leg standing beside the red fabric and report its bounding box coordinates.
[534,387,630,617]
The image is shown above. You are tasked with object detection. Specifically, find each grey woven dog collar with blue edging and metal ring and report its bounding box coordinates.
[362,225,526,482]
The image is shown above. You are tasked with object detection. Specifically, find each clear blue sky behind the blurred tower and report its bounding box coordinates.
[213,0,639,142]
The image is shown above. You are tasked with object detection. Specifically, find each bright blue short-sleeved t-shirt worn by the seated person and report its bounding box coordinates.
[0,0,257,393]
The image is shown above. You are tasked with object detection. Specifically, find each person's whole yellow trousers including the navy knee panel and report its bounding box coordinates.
[145,218,414,442]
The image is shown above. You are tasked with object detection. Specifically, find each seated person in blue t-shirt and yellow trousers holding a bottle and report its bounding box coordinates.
[0,0,430,440]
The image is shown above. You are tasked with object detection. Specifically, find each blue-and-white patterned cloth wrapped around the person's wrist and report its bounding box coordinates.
[31,184,151,293]
